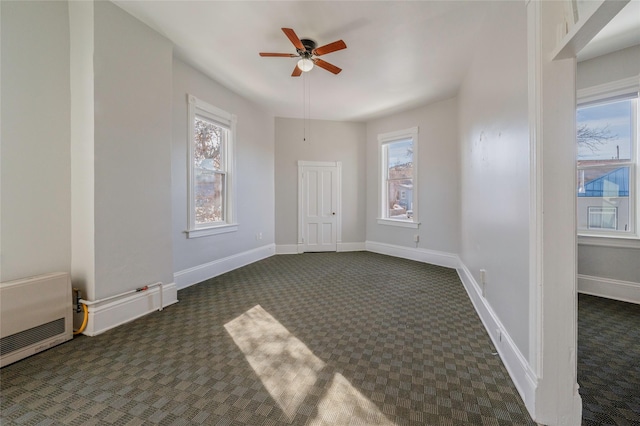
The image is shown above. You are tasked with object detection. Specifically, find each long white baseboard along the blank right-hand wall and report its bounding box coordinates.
[458,262,538,413]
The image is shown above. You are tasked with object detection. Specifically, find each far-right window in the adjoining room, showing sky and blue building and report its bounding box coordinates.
[576,79,639,238]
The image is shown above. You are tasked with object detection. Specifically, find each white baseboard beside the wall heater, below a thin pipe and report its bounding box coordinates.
[82,283,178,336]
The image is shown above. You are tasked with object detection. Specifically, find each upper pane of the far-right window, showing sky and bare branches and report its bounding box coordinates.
[577,99,635,164]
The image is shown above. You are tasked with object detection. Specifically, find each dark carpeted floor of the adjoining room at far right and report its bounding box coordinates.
[578,294,640,426]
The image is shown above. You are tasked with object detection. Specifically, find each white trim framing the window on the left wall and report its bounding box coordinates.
[185,95,238,238]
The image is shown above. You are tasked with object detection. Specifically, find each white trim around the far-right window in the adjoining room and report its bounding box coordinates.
[576,74,640,243]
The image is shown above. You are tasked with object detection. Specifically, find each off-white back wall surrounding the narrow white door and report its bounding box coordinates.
[275,118,367,250]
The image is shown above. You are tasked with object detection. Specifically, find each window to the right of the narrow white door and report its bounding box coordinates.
[378,127,419,228]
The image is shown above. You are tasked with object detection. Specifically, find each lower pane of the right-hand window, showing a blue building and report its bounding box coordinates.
[577,166,632,232]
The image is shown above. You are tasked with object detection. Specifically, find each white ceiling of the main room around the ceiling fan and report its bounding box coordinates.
[114,0,638,121]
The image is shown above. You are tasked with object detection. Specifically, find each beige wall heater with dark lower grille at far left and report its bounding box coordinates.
[0,273,73,367]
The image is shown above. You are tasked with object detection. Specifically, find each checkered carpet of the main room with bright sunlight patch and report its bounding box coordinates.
[0,252,534,426]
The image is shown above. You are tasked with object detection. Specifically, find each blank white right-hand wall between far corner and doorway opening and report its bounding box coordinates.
[459,2,529,360]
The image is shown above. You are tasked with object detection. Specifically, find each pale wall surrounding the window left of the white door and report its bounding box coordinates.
[168,58,274,287]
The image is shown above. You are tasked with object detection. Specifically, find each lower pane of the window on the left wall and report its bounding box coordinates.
[195,168,225,225]
